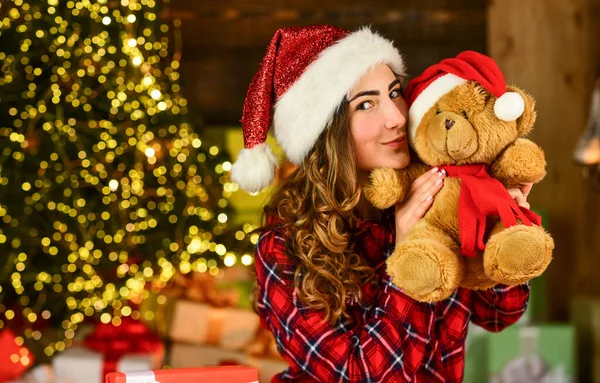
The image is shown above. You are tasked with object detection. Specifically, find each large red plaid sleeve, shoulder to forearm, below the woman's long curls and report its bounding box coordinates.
[255,231,433,382]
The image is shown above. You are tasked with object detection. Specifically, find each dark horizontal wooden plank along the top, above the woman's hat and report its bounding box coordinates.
[165,0,485,51]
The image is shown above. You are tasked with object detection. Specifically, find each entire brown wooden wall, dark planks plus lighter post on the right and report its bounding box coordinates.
[168,0,600,320]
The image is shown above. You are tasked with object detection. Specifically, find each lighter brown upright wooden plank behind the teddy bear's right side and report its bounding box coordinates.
[488,0,600,320]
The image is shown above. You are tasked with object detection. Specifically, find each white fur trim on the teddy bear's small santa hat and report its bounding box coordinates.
[408,73,467,148]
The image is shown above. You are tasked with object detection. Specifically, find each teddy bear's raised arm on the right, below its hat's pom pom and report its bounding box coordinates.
[490,138,546,188]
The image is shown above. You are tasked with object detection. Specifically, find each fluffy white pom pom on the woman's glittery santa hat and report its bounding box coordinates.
[231,143,277,193]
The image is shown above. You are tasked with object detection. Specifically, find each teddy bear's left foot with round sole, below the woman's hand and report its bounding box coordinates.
[387,239,464,302]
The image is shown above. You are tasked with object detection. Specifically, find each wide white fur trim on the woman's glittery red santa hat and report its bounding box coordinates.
[273,27,405,165]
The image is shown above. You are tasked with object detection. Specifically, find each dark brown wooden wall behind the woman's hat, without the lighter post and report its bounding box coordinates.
[169,0,485,125]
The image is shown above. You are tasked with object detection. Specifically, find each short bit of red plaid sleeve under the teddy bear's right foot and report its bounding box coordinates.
[471,282,530,332]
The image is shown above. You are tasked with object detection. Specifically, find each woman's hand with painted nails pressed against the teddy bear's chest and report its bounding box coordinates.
[396,168,446,243]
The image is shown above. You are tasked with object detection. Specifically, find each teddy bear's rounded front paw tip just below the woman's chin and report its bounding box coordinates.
[363,168,410,209]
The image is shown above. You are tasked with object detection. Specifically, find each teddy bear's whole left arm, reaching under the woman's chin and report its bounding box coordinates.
[364,163,429,209]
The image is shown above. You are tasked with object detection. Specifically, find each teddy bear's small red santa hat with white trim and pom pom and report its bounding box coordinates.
[405,51,525,145]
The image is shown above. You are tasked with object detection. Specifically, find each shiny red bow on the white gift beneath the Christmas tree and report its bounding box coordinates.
[83,317,164,376]
